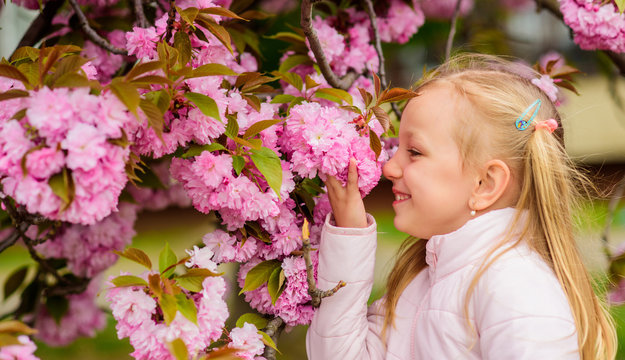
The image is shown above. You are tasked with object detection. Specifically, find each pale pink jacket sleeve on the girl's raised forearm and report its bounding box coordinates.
[306,214,385,360]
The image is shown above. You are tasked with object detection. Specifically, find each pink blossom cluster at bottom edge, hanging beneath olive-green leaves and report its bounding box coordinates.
[106,273,228,360]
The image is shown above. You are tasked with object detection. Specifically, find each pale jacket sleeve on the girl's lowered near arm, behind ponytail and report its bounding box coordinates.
[476,255,579,360]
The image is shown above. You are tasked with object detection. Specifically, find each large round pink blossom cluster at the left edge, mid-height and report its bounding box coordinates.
[0,80,136,225]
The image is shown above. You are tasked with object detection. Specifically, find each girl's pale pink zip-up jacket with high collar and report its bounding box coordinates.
[306,208,579,360]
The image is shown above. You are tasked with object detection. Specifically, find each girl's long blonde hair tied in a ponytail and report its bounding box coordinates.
[382,54,617,359]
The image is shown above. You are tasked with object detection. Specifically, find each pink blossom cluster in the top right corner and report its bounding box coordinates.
[560,0,625,53]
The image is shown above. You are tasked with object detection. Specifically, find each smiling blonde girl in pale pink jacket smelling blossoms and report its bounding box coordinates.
[307,56,616,360]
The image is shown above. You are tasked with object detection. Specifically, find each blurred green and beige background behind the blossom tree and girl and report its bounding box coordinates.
[0,0,625,360]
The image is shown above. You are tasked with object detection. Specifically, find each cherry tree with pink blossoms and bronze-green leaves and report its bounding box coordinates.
[0,0,625,359]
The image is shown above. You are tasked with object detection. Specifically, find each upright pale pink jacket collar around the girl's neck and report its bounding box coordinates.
[425,208,517,283]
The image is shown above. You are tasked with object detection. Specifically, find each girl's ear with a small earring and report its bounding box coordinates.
[469,159,510,211]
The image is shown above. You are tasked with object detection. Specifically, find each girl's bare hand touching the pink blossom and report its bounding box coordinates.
[326,158,367,228]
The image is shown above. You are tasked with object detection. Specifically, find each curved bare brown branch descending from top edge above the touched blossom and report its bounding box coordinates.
[300,0,358,90]
